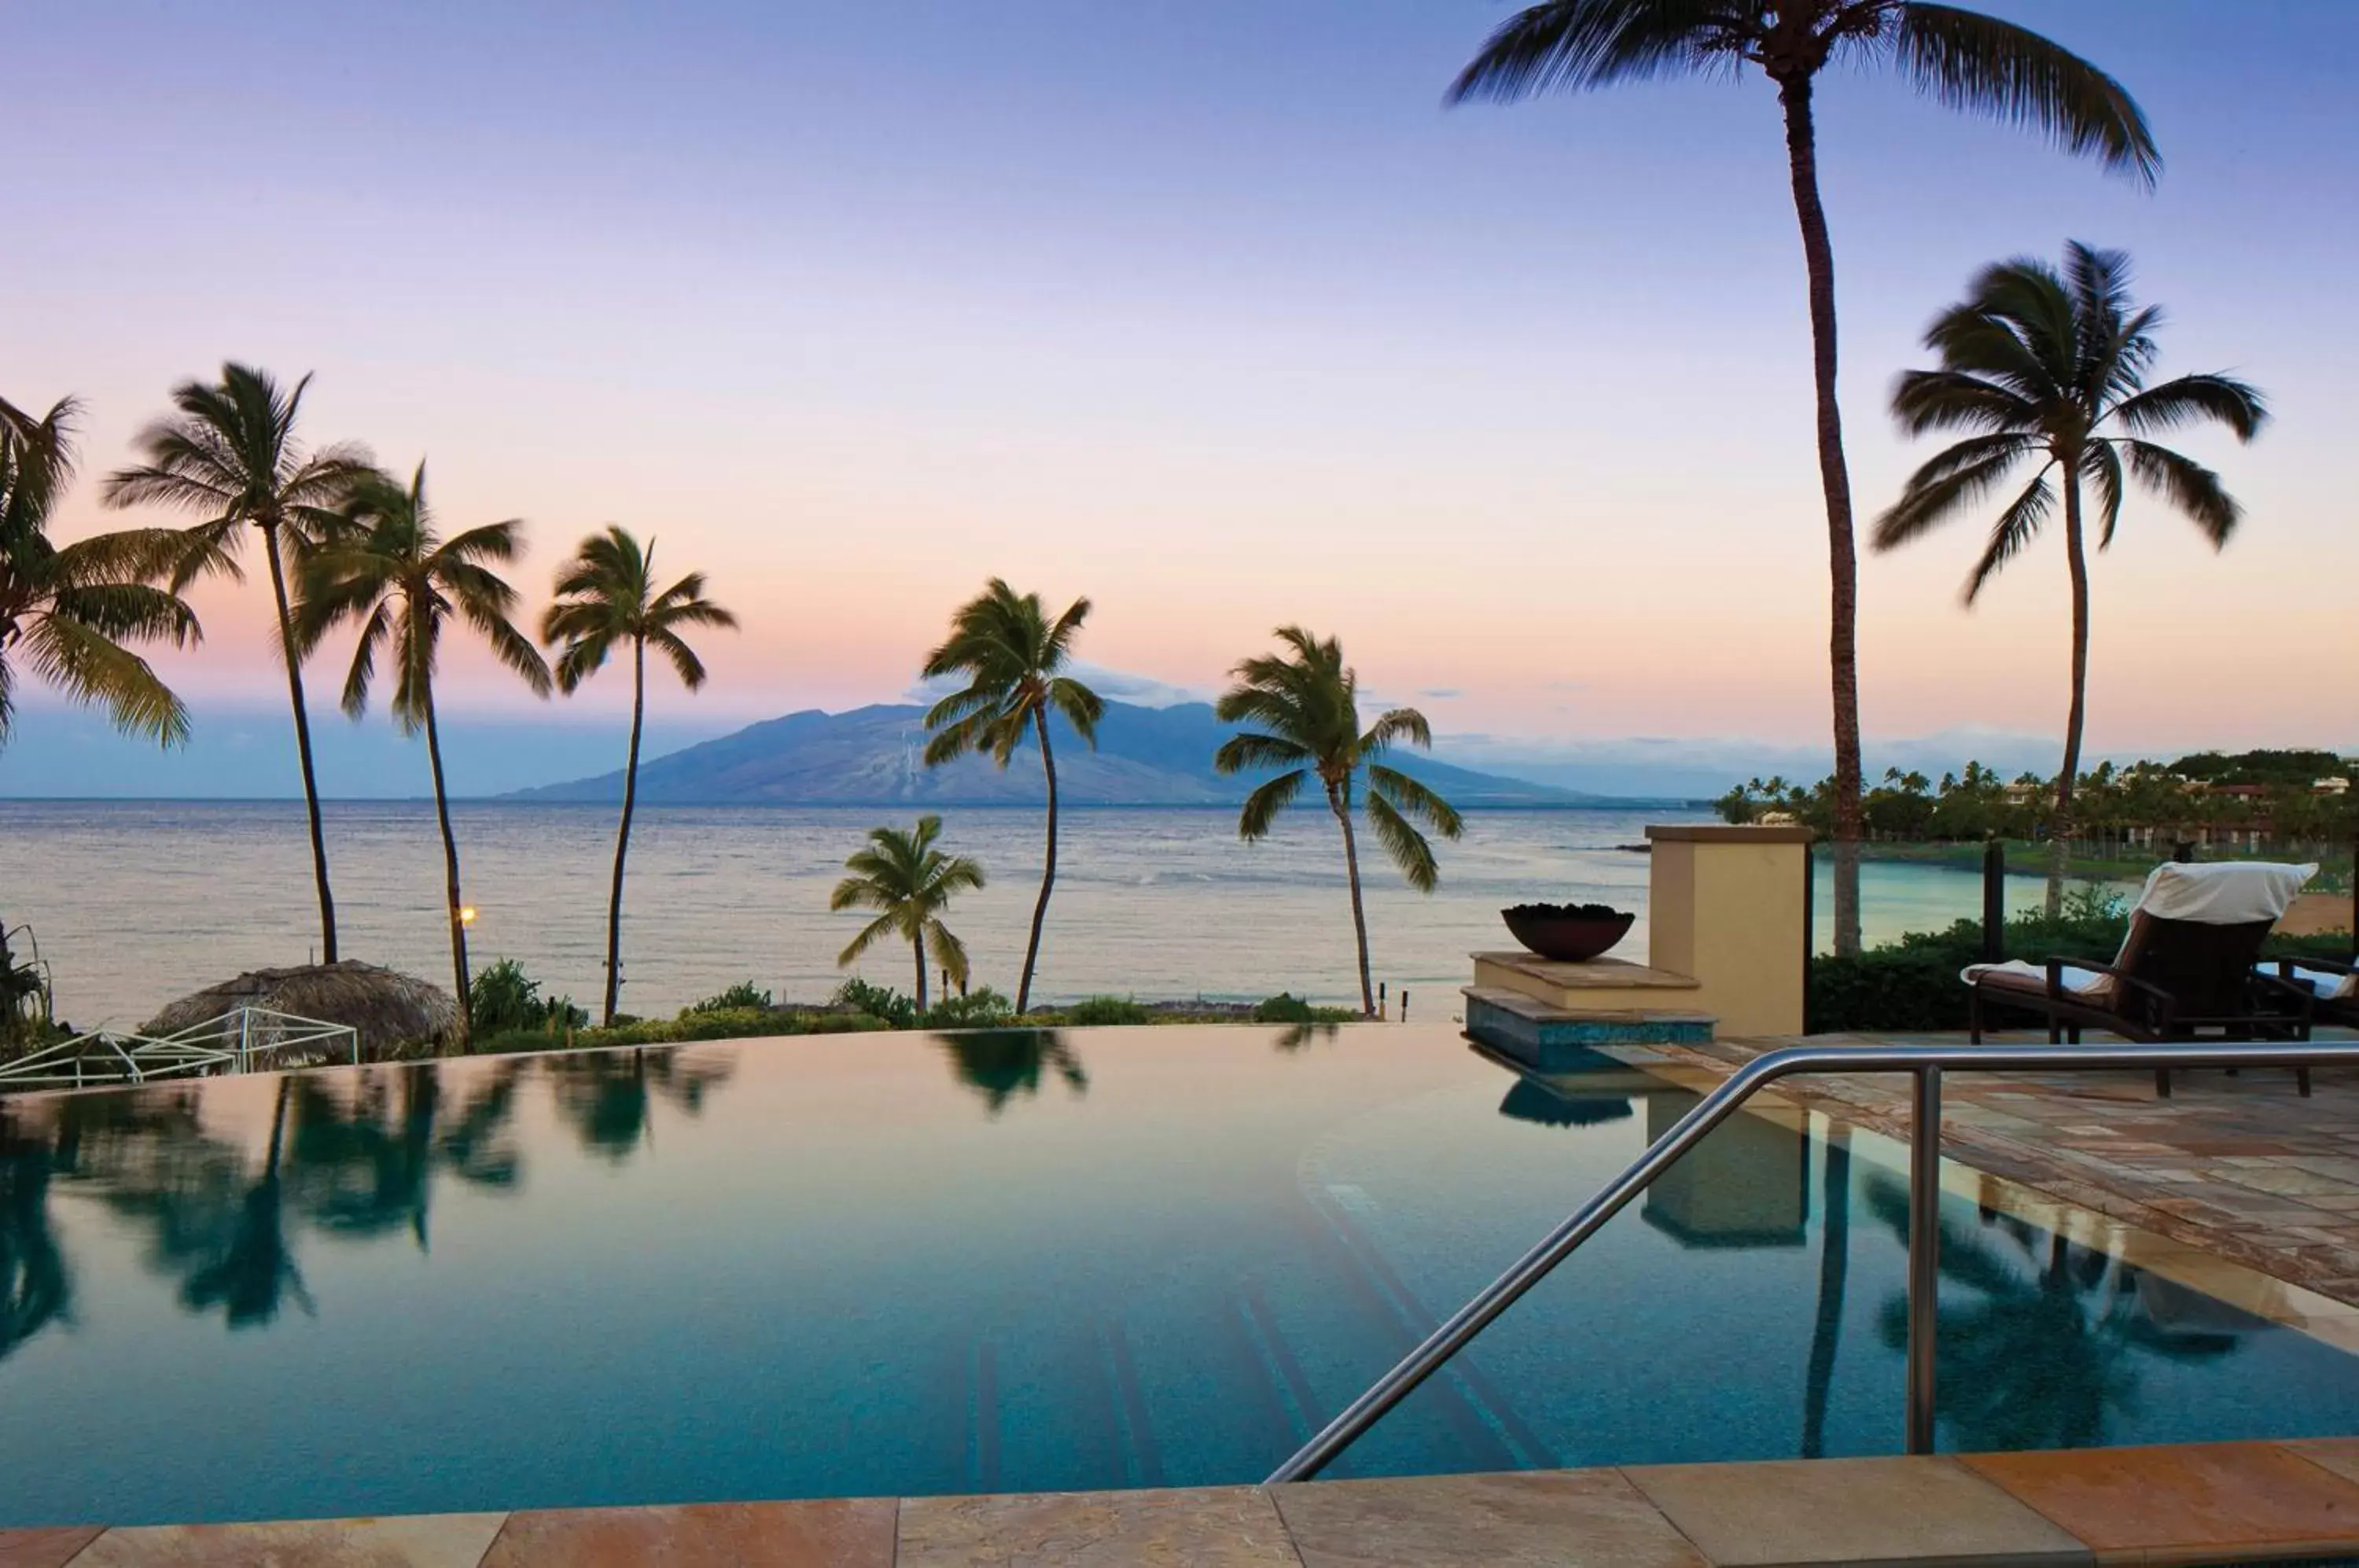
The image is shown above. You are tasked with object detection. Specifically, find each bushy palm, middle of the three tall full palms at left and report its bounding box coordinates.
[293,462,550,1044]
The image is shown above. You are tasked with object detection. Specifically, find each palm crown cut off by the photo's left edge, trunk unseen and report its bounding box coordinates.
[0,399,203,748]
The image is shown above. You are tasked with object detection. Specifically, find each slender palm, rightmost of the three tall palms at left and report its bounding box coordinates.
[540,526,736,1025]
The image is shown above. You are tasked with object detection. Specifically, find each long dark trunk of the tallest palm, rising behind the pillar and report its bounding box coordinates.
[1779,75,1861,952]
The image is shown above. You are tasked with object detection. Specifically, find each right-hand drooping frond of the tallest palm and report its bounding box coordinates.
[1892,0,2163,184]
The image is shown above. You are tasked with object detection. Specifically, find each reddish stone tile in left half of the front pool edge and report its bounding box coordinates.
[484,1497,894,1568]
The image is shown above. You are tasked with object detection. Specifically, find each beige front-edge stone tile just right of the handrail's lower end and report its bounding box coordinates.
[1272,1469,1706,1568]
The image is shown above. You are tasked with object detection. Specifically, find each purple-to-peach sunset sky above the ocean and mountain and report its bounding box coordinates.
[0,0,2359,792]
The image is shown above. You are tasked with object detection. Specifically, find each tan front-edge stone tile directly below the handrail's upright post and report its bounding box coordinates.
[1623,1459,2090,1568]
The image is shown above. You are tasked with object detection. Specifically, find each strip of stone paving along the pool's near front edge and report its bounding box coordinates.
[13,1438,2359,1568]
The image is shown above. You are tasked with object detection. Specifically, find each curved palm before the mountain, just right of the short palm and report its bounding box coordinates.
[925,578,1106,1014]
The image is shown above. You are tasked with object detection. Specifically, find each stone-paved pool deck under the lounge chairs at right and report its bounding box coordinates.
[1609,1030,2359,1351]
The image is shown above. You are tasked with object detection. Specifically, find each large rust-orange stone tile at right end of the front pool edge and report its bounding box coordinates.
[1963,1443,2359,1568]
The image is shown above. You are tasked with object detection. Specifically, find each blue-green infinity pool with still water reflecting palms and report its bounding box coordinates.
[0,1025,2359,1526]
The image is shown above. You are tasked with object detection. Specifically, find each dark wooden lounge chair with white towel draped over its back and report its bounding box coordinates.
[1960,860,2319,1094]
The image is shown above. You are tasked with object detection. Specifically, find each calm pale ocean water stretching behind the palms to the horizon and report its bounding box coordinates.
[0,799,2038,1028]
